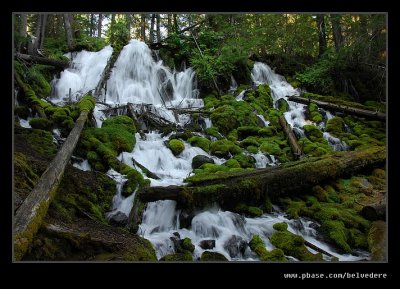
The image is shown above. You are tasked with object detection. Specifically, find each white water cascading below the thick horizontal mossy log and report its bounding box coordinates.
[138,201,368,261]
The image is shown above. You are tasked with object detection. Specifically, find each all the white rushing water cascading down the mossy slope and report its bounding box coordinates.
[53,40,368,261]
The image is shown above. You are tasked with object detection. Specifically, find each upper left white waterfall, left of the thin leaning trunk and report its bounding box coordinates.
[52,46,112,103]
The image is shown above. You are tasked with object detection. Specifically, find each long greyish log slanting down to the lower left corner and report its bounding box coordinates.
[14,111,89,260]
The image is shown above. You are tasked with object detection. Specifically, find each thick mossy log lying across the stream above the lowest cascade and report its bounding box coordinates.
[138,147,386,209]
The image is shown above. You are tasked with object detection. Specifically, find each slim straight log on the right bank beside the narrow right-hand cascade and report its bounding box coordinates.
[289,96,386,121]
